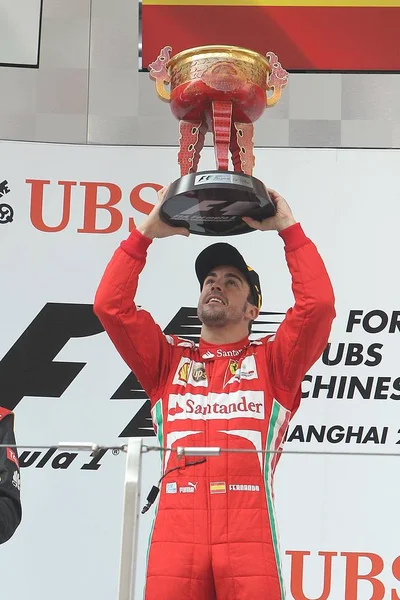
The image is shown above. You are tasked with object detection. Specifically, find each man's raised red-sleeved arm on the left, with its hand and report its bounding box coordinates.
[93,189,188,399]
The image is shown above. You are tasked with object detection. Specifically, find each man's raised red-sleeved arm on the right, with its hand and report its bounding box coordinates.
[242,190,336,408]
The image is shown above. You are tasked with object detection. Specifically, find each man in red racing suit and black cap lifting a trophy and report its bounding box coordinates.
[95,185,335,600]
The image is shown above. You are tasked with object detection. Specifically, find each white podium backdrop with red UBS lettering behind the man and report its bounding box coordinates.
[0,142,400,600]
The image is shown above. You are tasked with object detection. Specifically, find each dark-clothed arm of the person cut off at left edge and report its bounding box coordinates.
[0,406,22,544]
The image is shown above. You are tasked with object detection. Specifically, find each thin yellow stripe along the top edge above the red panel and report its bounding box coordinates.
[142,0,400,8]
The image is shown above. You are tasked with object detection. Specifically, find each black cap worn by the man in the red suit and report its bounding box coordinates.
[195,242,262,308]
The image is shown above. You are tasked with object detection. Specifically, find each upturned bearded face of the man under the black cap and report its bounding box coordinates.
[197,266,258,327]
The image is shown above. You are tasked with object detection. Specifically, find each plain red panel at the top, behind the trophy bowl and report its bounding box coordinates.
[142,5,400,71]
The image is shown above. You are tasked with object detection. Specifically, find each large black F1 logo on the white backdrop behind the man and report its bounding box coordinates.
[0,303,284,437]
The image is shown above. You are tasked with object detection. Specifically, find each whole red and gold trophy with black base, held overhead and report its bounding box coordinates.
[149,46,288,236]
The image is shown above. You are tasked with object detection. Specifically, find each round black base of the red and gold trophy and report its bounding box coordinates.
[160,171,276,236]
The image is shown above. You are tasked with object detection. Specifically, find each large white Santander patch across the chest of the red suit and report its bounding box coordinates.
[168,390,265,421]
